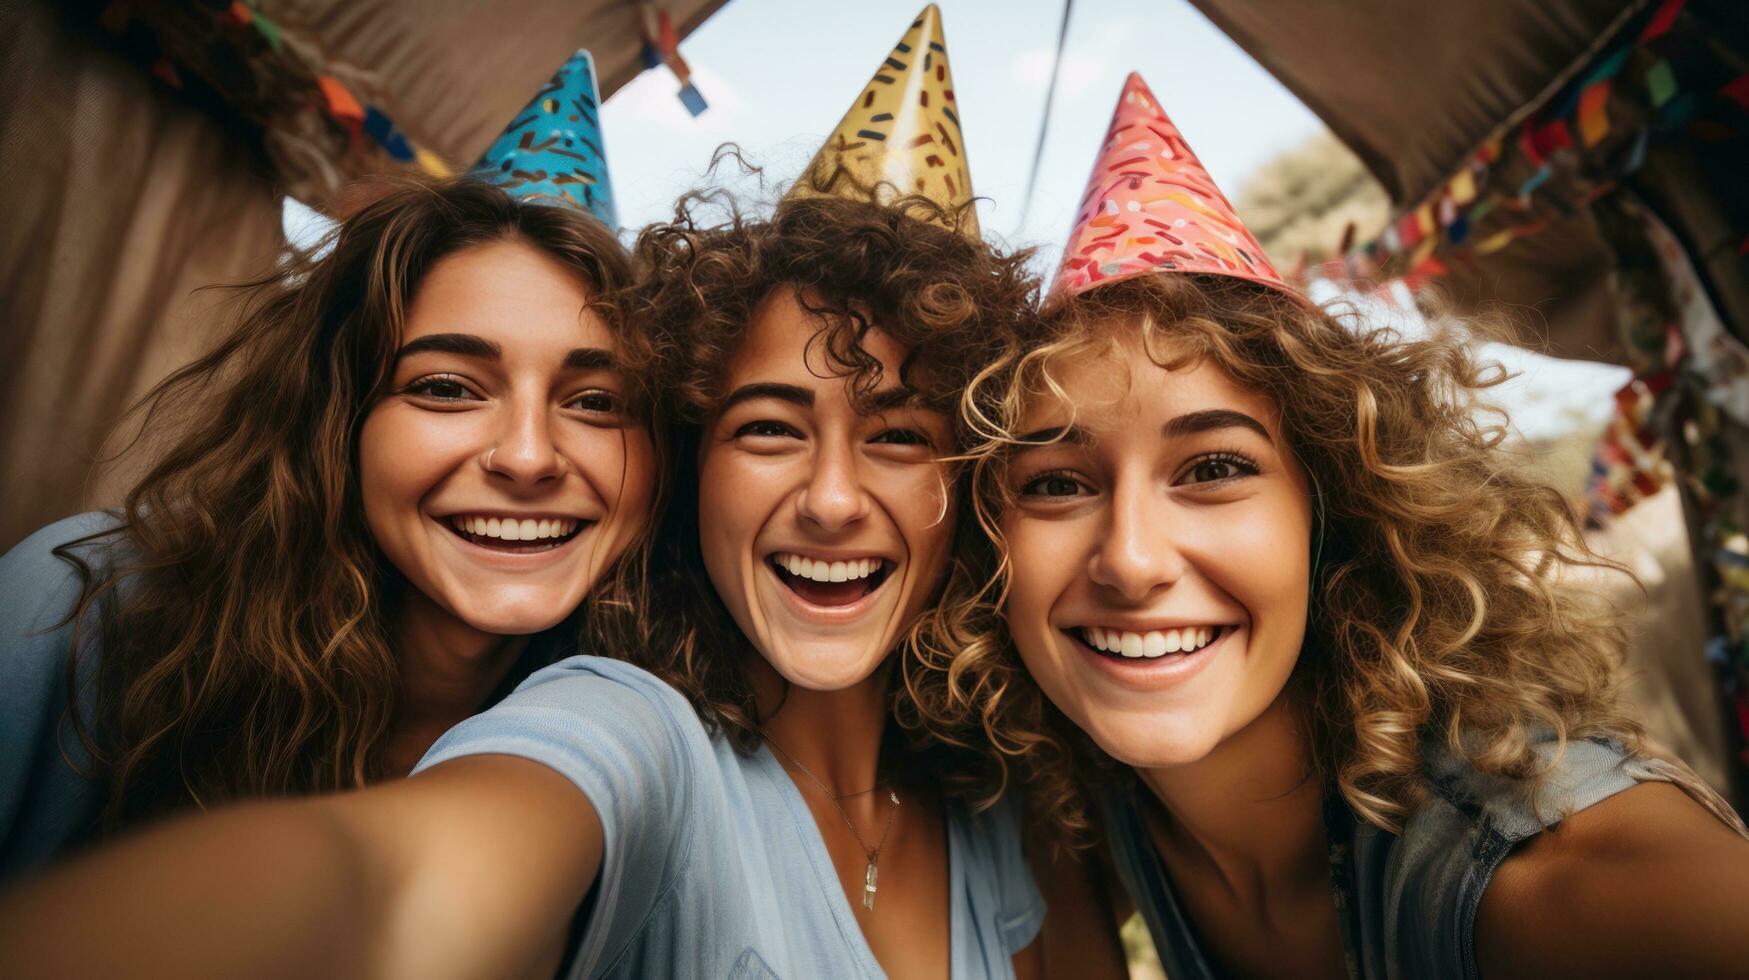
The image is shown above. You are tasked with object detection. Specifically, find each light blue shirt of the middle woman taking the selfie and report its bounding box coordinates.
[415,656,1044,980]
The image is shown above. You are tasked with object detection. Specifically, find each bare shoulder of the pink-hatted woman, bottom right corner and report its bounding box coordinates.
[1476,781,1749,977]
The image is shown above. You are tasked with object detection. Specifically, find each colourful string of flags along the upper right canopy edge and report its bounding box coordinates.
[1331,0,1749,287]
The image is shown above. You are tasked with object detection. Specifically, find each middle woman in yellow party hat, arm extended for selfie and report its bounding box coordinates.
[0,7,1121,977]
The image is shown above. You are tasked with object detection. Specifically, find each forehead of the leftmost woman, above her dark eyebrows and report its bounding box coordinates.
[402,240,614,354]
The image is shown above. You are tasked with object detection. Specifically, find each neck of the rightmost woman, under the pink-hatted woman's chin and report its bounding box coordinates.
[1139,691,1329,905]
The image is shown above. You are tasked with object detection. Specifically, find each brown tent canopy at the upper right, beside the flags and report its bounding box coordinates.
[1191,0,1749,362]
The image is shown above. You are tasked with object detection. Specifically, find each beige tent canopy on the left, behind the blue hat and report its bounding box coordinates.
[0,0,724,551]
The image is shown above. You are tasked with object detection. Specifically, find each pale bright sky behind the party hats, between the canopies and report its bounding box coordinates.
[603,0,1322,267]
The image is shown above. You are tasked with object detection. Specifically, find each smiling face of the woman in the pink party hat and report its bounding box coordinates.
[1002,326,1312,768]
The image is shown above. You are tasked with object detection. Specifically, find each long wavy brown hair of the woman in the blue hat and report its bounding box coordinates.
[56,179,651,830]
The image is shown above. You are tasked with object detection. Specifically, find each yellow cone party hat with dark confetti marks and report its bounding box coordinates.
[789,4,978,238]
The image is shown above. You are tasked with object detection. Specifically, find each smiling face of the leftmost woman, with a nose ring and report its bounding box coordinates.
[359,240,656,635]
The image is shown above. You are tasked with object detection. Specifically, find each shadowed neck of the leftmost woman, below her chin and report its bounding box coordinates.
[390,588,528,774]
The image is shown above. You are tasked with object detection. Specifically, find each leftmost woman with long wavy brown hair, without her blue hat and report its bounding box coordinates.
[0,180,658,877]
